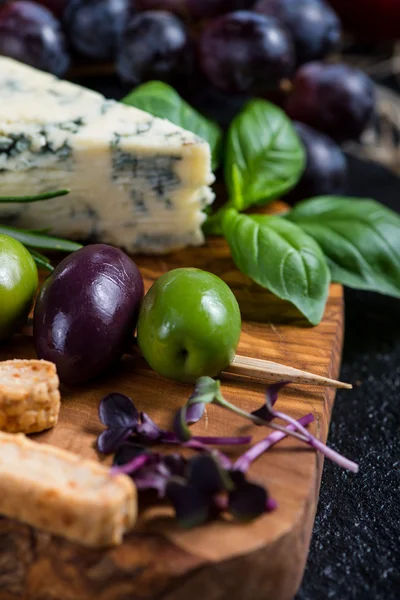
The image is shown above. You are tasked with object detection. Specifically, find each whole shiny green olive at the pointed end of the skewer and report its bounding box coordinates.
[137,268,241,382]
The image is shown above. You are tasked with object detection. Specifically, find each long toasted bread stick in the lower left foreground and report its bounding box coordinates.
[0,433,137,548]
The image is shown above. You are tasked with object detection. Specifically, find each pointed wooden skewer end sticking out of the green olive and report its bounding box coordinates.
[224,355,353,390]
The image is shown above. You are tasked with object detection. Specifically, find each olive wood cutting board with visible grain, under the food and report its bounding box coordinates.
[0,239,343,600]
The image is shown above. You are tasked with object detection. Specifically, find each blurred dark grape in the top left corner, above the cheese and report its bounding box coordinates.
[0,0,70,76]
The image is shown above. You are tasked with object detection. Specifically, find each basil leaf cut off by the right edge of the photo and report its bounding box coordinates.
[286,196,400,298]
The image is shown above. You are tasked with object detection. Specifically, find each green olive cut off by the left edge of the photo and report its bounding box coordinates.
[0,234,39,340]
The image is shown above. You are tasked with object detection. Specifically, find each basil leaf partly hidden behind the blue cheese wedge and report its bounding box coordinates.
[122,81,222,170]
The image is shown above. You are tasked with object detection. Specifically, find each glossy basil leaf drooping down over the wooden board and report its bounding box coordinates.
[222,209,330,325]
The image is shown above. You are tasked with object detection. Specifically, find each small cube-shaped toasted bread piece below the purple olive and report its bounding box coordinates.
[0,360,60,433]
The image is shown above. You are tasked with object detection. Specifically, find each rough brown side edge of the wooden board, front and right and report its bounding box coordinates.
[0,292,343,600]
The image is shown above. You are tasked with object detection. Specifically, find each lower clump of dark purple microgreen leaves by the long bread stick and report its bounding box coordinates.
[112,443,273,527]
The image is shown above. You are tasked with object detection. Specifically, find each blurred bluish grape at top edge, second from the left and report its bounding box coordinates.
[64,0,132,60]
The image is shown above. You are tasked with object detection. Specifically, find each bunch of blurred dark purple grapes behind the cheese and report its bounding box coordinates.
[0,0,374,202]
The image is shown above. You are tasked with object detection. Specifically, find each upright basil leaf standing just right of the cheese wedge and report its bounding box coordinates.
[225,100,305,210]
